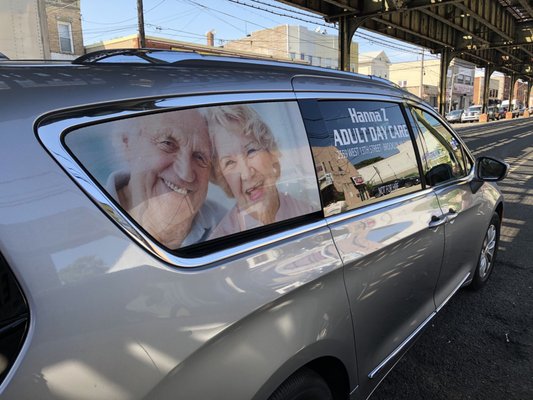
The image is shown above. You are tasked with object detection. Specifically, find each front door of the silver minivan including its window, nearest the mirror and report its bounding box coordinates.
[411,106,486,308]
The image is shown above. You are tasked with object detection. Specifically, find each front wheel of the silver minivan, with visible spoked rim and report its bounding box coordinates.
[470,213,501,290]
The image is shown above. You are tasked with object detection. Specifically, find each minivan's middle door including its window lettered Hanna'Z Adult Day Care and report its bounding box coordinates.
[300,95,444,393]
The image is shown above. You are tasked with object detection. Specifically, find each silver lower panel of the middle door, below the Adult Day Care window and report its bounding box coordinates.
[331,192,444,392]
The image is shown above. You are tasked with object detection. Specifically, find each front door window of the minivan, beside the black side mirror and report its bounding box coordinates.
[412,107,466,186]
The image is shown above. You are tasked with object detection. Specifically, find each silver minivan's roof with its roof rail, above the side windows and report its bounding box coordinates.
[0,49,416,115]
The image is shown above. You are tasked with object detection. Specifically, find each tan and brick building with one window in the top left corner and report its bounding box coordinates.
[0,0,84,60]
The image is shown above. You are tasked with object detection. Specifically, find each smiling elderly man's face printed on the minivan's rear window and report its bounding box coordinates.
[125,110,211,248]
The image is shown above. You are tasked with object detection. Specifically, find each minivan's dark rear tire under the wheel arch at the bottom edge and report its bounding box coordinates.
[268,368,333,400]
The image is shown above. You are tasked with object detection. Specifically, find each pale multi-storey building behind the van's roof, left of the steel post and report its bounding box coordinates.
[224,25,358,72]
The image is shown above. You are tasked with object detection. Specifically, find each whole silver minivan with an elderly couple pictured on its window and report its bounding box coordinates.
[0,50,508,400]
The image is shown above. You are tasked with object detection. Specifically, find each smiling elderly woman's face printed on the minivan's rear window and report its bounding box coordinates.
[212,123,280,223]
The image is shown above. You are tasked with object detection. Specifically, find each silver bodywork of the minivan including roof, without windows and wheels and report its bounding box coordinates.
[0,53,502,400]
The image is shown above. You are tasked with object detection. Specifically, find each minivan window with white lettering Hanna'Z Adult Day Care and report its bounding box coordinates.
[301,100,421,216]
